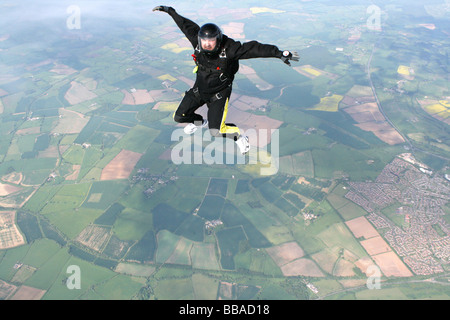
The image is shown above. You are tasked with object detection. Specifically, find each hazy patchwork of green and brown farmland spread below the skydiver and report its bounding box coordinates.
[0,0,450,300]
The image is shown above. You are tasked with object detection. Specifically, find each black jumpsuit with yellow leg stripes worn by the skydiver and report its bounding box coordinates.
[168,8,282,140]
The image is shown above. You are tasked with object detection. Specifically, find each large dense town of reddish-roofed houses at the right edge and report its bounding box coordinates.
[345,158,450,275]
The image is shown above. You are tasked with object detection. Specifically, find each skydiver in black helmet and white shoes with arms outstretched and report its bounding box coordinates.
[153,6,299,154]
